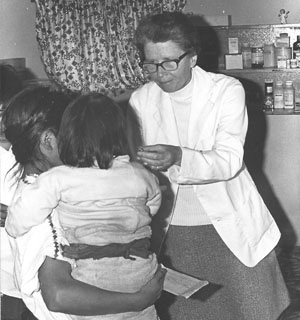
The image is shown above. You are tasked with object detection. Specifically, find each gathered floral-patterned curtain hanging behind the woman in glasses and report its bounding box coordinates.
[36,0,186,95]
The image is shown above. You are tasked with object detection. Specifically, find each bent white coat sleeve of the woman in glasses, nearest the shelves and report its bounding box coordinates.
[169,81,248,184]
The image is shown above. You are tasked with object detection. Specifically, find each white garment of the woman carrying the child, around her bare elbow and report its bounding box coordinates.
[11,216,74,320]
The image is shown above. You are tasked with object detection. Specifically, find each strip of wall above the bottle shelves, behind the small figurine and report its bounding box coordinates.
[185,0,300,25]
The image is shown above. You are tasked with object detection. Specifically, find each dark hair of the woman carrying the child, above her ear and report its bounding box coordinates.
[3,86,71,166]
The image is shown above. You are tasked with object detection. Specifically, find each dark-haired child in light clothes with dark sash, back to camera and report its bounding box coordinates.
[6,94,161,320]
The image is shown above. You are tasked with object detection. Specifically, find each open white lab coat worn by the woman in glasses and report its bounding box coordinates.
[130,67,280,267]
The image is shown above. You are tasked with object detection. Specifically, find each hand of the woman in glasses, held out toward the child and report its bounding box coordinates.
[137,144,182,171]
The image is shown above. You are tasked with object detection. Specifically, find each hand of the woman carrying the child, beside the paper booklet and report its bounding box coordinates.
[137,265,167,310]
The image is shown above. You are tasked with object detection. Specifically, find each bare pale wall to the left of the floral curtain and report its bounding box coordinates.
[0,0,47,78]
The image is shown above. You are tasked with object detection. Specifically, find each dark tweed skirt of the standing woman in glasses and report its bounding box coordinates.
[156,225,289,320]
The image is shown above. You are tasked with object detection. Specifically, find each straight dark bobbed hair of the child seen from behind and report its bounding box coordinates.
[58,93,129,169]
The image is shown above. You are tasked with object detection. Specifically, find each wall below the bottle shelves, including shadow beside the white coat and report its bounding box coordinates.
[245,106,300,247]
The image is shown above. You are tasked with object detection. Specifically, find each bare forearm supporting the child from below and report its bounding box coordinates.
[39,258,163,316]
